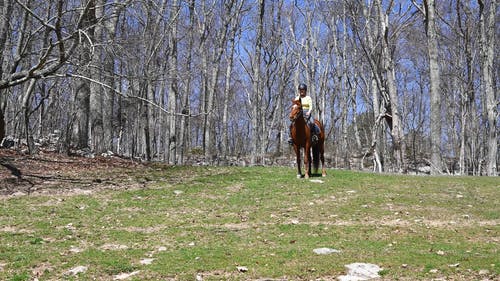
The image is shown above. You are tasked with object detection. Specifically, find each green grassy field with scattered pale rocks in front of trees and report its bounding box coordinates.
[0,165,500,280]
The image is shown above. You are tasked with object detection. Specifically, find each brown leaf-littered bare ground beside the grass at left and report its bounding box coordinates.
[0,149,147,196]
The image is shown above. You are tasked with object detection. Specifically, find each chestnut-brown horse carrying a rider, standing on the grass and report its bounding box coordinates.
[290,99,326,179]
